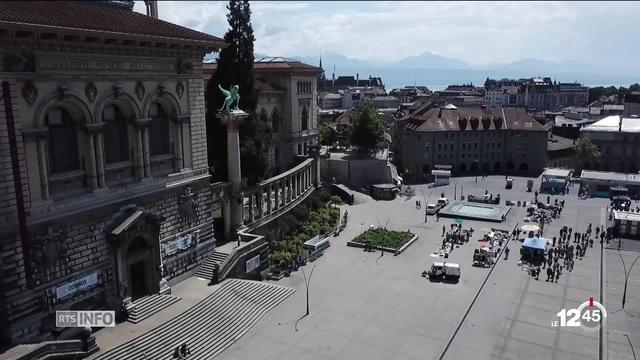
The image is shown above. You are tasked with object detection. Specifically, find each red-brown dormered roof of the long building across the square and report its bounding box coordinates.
[403,104,546,131]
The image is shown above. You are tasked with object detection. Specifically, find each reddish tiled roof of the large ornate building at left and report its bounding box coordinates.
[0,1,224,48]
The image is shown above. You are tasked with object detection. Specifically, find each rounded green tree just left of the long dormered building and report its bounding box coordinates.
[351,101,384,152]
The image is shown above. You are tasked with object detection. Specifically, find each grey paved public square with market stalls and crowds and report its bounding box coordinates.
[98,176,640,360]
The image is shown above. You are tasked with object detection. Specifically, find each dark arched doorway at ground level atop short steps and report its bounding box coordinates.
[127,237,153,300]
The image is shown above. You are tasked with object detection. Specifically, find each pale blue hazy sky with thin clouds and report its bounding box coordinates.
[135,1,640,71]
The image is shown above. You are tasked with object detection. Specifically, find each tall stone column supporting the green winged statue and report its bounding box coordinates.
[217,111,249,229]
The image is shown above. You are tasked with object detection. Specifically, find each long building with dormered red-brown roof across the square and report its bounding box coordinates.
[393,103,549,180]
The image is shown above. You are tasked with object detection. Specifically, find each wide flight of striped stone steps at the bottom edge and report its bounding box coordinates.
[97,279,295,360]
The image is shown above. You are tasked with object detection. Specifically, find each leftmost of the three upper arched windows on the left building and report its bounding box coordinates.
[45,108,80,174]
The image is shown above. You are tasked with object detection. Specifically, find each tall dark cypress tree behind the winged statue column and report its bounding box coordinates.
[207,0,271,183]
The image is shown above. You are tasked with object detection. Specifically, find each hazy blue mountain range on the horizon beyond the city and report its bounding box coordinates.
[205,52,640,90]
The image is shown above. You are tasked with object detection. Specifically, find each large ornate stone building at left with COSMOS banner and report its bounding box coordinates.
[0,2,228,343]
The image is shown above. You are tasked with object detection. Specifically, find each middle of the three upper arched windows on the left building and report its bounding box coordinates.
[102,105,129,164]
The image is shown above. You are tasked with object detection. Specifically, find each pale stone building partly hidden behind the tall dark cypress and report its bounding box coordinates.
[203,57,322,177]
